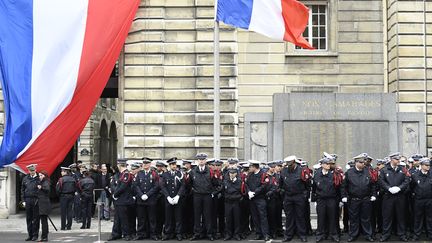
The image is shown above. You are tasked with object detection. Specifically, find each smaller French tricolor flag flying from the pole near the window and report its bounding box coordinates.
[216,0,314,49]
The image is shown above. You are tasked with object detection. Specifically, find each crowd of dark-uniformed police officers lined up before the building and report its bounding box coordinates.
[22,153,432,242]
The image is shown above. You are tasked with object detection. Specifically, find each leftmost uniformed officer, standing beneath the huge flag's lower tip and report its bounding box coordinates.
[21,164,39,241]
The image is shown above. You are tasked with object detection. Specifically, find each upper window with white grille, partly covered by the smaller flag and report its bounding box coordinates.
[295,4,328,51]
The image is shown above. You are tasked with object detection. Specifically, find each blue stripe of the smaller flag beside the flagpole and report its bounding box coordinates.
[216,0,253,29]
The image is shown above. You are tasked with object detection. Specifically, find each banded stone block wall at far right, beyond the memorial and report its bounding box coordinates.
[387,0,432,155]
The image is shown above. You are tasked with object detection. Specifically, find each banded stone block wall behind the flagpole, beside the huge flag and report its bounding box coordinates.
[120,0,238,159]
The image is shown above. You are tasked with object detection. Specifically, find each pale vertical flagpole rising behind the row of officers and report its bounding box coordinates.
[213,20,220,159]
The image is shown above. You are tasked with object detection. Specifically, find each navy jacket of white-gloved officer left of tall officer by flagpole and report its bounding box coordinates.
[160,171,186,197]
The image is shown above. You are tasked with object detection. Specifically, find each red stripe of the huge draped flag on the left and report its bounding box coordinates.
[15,0,140,174]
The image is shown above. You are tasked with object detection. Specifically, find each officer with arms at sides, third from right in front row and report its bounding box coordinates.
[342,154,376,242]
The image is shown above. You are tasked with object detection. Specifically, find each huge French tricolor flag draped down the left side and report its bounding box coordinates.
[0,0,140,174]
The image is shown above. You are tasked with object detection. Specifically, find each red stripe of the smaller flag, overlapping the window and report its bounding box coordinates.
[281,0,315,49]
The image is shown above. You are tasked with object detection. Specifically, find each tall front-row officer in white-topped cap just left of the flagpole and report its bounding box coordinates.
[190,153,217,241]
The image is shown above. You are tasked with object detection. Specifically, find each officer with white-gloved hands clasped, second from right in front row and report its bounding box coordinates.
[379,153,410,242]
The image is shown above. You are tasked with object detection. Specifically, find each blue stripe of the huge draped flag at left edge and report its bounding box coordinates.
[0,0,33,167]
